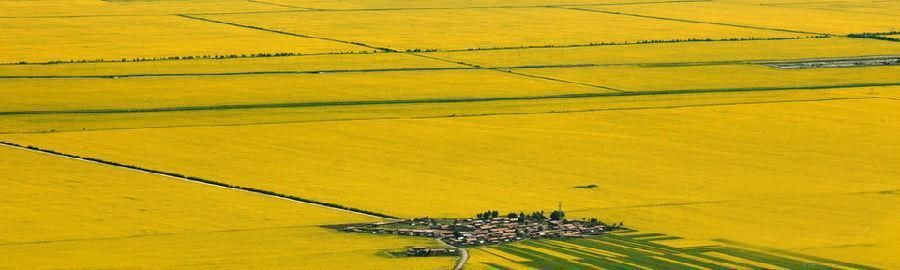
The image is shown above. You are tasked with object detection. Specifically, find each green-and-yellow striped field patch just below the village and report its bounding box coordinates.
[474,232,872,270]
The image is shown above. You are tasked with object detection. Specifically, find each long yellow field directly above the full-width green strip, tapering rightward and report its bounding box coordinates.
[0,70,609,112]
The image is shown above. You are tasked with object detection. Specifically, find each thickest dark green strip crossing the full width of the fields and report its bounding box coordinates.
[0,82,900,116]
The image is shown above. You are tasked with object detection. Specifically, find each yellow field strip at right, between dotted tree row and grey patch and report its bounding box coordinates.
[430,38,900,67]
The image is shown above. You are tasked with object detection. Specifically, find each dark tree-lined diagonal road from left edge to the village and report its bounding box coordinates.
[0,141,398,220]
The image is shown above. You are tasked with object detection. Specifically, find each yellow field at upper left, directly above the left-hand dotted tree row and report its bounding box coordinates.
[0,16,369,63]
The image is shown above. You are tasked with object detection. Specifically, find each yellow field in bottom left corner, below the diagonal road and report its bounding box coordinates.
[0,146,452,269]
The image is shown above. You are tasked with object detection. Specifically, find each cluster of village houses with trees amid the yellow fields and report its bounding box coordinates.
[342,217,607,247]
